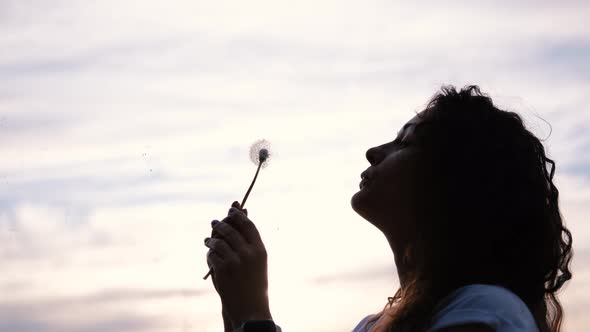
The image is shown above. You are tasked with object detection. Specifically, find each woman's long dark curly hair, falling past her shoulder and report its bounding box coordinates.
[374,86,573,332]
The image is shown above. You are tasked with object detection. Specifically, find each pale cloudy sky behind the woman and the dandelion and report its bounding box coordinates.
[0,0,590,332]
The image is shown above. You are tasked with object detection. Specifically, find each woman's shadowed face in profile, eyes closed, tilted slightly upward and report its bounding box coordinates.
[351,115,428,236]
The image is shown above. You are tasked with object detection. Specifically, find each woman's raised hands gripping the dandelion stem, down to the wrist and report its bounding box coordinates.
[205,202,272,328]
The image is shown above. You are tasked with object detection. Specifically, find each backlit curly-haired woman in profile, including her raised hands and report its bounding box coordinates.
[205,86,573,332]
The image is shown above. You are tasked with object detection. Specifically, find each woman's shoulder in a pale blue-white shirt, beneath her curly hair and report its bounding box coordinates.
[429,284,538,332]
